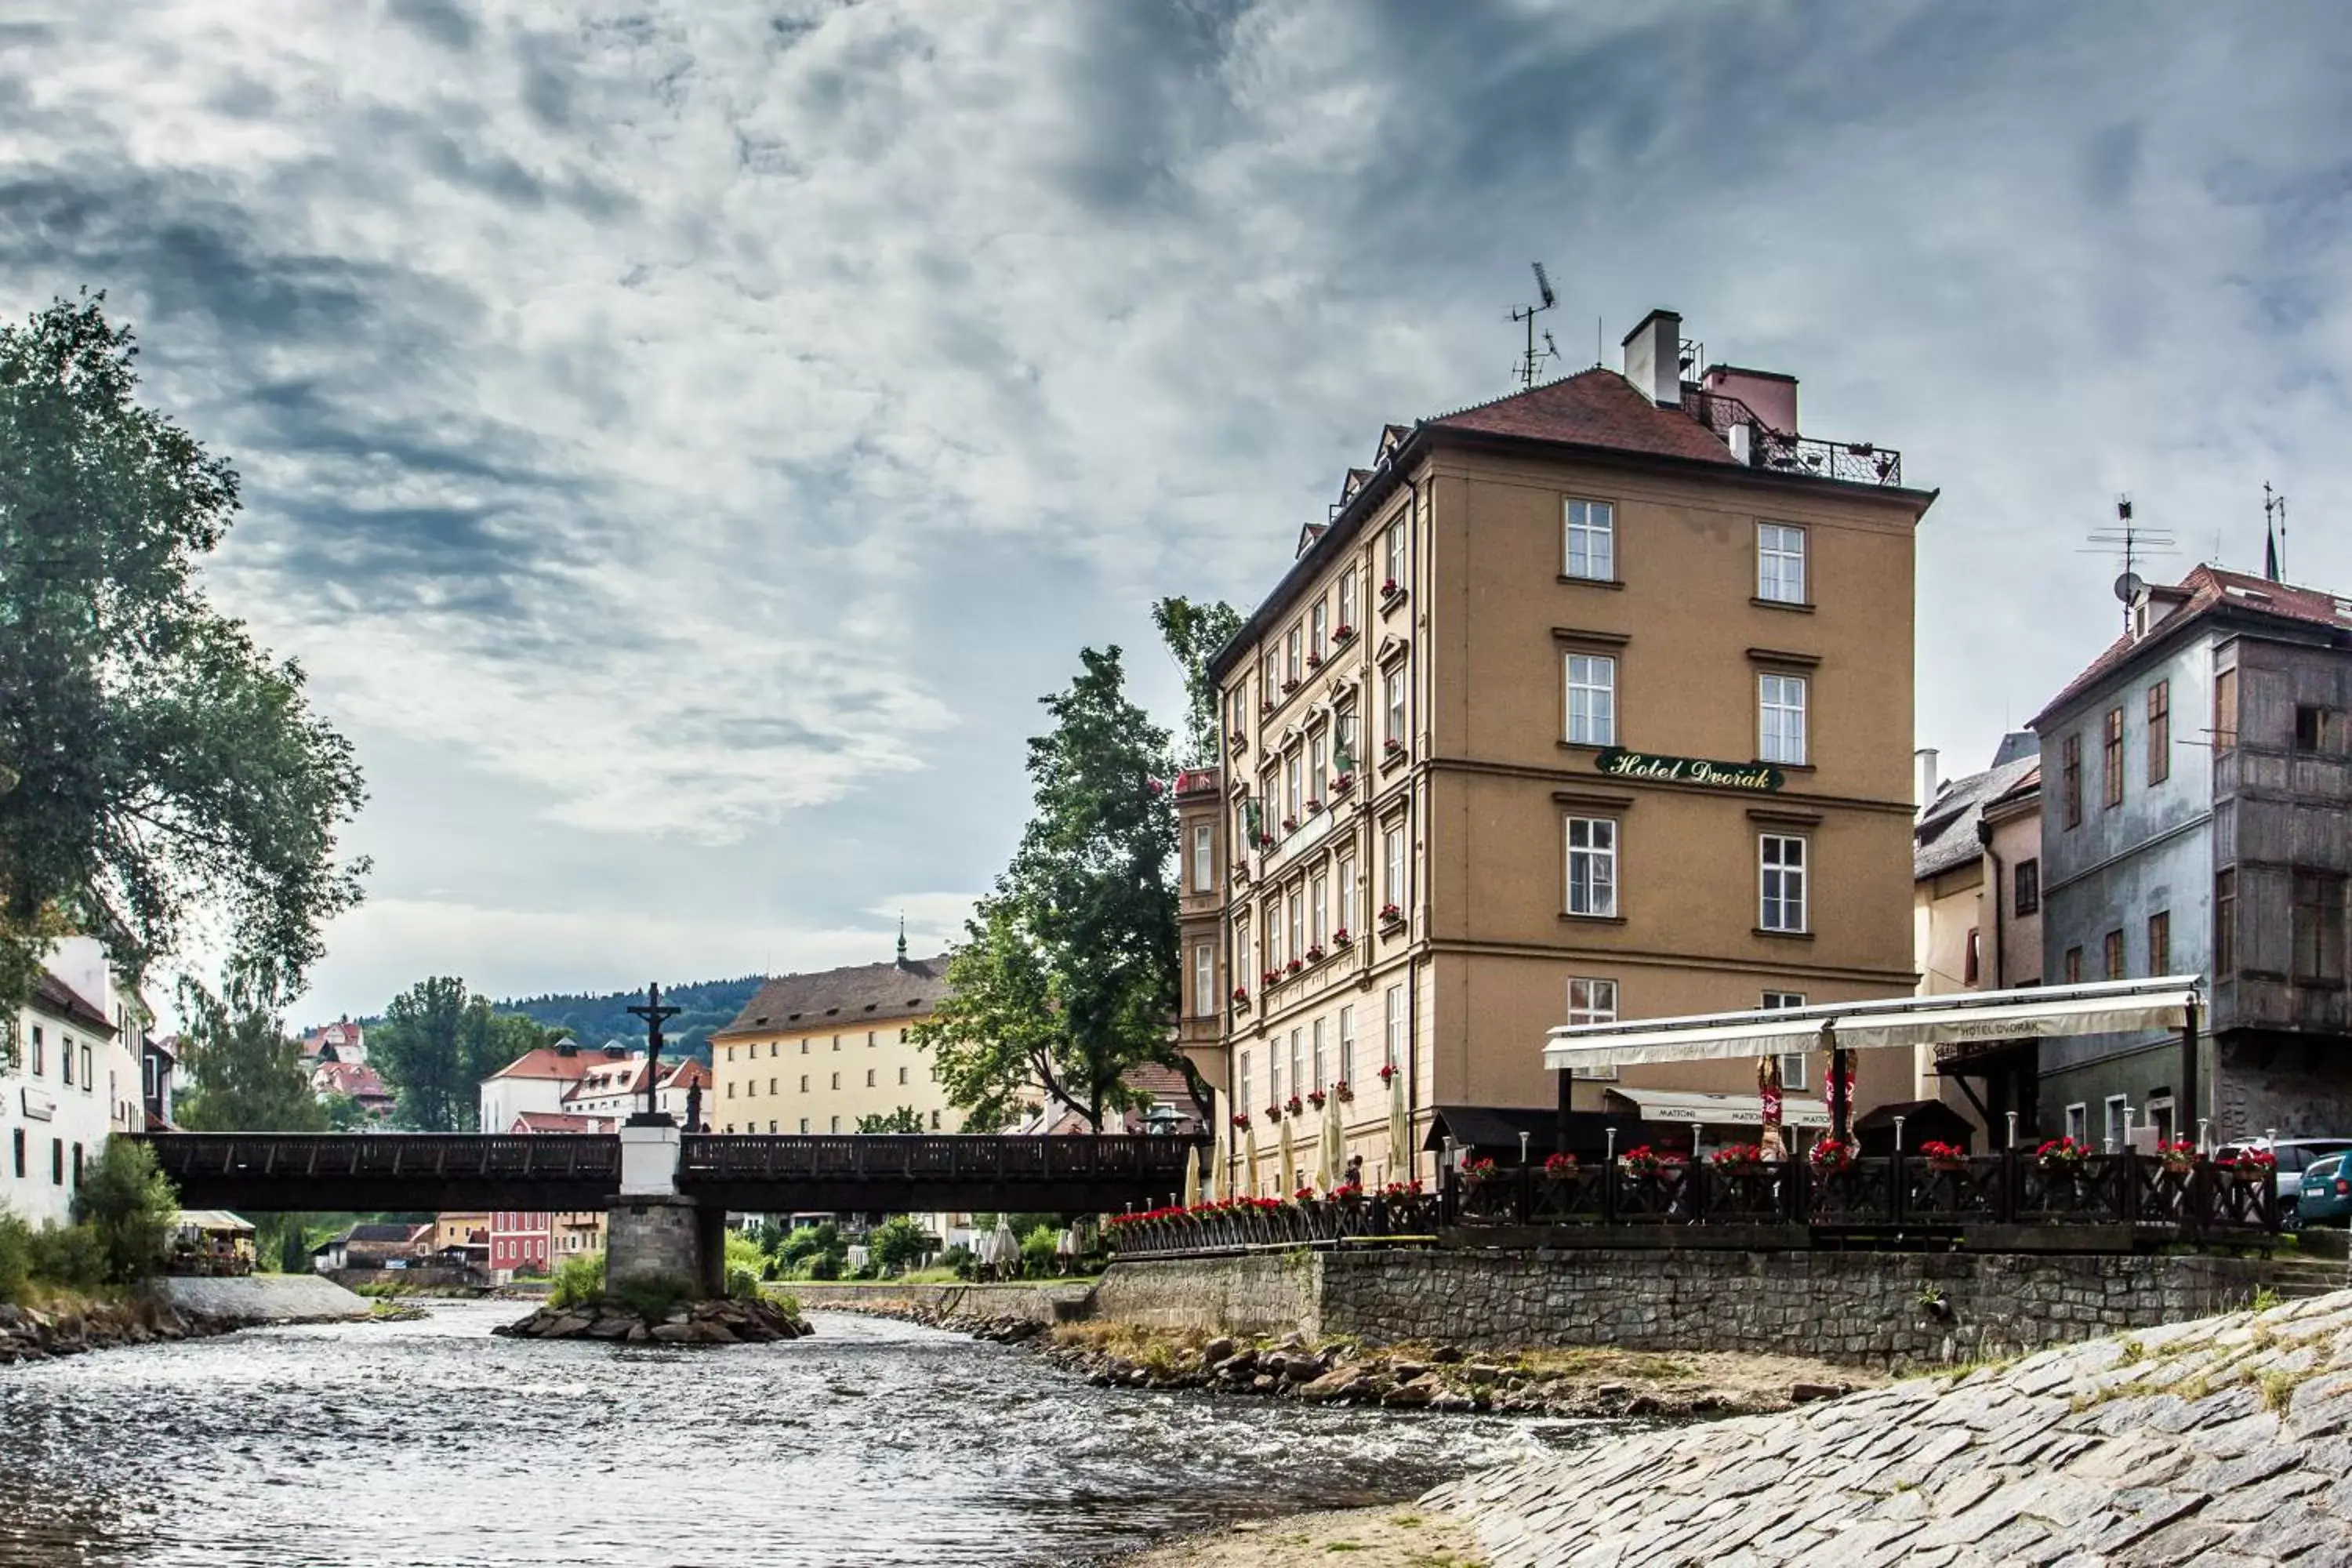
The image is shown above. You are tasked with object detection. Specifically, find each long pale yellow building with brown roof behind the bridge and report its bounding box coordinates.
[703,938,962,1133]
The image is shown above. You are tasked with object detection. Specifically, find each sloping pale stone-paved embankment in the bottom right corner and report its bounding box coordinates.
[1423,1293,2352,1568]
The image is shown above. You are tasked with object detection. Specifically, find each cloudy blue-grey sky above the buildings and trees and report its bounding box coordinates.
[0,0,2352,1015]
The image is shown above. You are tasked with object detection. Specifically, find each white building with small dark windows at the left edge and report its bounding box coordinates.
[0,938,146,1225]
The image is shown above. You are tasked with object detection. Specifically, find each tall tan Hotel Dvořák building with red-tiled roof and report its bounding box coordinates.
[1178,310,1933,1192]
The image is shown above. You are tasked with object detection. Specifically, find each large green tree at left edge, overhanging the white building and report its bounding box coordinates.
[0,294,367,1044]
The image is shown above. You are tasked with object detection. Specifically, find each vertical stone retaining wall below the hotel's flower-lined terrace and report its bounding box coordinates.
[1091,1248,2272,1370]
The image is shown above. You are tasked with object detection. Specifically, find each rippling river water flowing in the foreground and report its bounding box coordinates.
[0,1302,1595,1568]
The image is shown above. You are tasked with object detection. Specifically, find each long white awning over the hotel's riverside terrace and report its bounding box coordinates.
[1543,975,2199,1072]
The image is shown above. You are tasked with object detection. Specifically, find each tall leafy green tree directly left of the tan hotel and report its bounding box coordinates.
[913,649,1176,1128]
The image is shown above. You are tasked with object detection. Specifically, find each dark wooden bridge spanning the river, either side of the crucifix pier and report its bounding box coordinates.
[139,1133,1207,1215]
